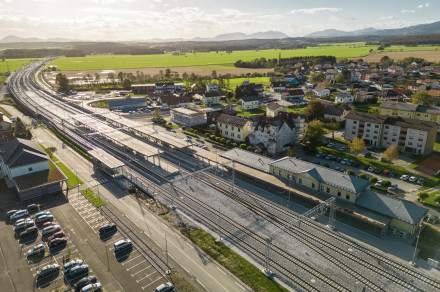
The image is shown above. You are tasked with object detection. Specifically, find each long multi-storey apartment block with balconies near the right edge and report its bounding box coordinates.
[345,111,438,155]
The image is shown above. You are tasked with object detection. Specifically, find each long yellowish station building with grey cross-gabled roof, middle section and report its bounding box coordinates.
[270,157,371,202]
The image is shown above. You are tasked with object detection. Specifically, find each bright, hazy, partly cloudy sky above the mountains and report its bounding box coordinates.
[0,0,440,41]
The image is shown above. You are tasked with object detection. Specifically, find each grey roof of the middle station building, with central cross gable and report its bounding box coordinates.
[271,157,371,193]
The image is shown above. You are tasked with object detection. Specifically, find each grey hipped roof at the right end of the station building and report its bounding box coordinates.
[355,190,428,224]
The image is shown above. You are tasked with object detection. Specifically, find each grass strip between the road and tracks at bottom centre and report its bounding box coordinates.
[185,228,288,291]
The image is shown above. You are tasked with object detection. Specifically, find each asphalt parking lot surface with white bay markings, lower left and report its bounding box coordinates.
[0,194,166,291]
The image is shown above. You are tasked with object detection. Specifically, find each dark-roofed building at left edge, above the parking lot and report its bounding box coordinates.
[0,139,67,200]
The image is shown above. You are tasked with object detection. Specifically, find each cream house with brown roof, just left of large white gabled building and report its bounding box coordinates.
[217,114,251,142]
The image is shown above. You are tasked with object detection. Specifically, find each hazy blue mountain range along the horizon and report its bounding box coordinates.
[0,21,440,43]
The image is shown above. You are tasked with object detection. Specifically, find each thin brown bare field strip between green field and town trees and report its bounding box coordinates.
[49,66,273,79]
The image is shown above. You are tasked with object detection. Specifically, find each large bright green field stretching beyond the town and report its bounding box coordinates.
[51,44,377,70]
